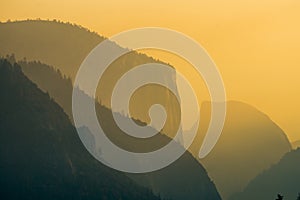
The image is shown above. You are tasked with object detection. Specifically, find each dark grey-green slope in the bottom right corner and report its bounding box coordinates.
[231,149,300,200]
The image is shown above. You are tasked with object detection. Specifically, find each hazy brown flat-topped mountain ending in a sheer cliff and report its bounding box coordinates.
[0,20,180,141]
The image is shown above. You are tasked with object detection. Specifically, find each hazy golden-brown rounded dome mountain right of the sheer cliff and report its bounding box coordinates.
[190,101,291,199]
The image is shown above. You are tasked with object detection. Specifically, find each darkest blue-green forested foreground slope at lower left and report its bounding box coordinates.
[0,59,159,200]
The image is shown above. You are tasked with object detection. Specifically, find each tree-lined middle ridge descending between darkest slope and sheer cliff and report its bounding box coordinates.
[9,57,220,200]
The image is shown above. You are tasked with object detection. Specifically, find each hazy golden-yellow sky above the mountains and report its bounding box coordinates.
[0,0,300,141]
